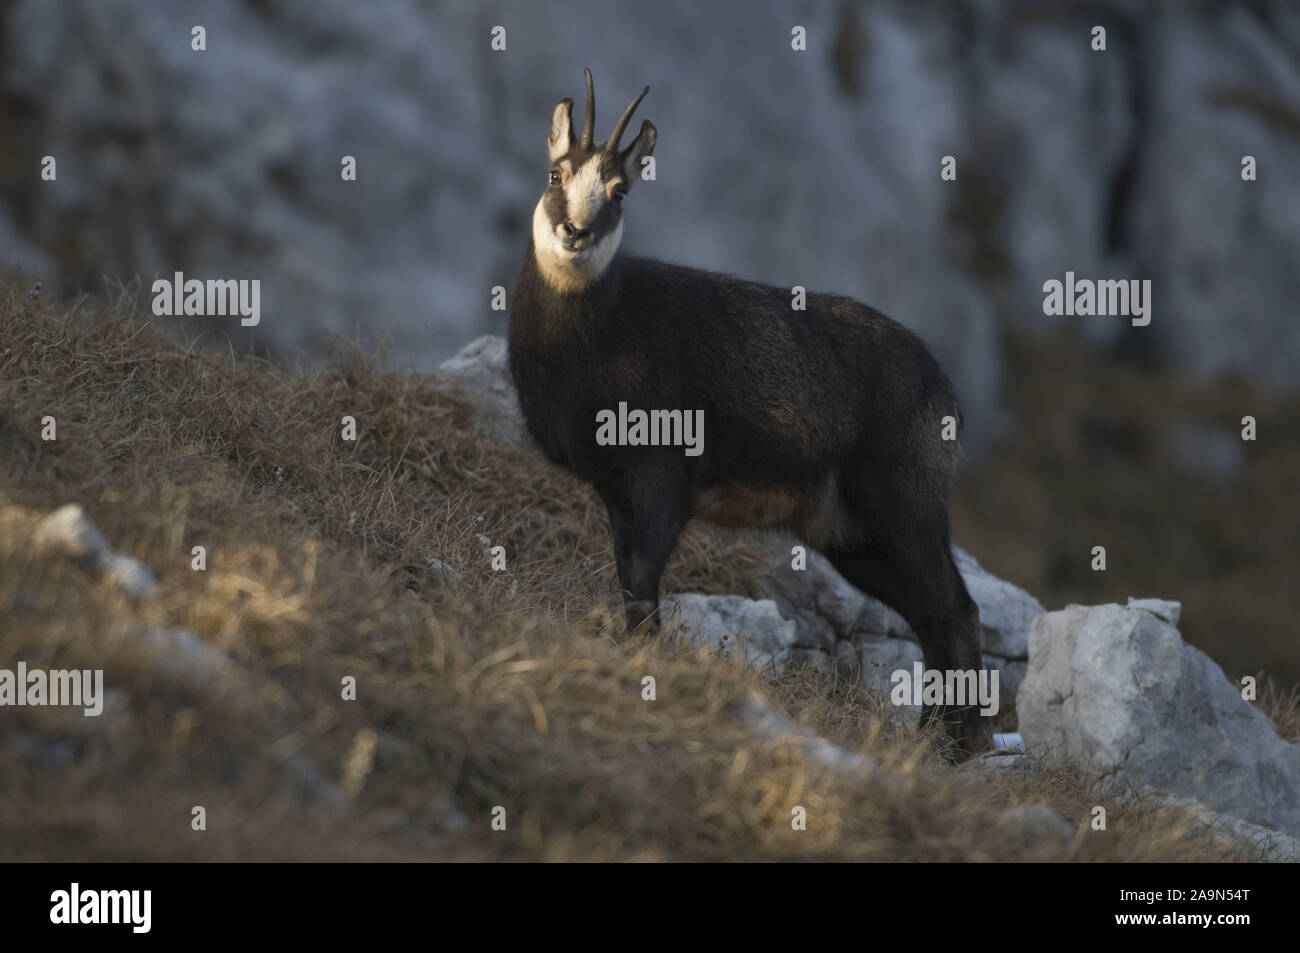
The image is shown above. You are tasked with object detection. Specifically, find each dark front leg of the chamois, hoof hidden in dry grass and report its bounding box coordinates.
[601,473,690,636]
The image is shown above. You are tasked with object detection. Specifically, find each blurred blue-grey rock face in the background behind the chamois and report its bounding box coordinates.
[0,0,1300,450]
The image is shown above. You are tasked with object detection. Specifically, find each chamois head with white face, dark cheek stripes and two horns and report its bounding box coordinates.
[533,70,655,293]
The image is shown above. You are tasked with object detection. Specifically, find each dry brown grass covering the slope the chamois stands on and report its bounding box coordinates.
[0,276,1295,861]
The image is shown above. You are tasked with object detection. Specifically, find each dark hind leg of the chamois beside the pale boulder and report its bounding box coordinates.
[827,515,993,759]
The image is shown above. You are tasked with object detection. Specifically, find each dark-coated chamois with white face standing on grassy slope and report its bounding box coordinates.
[510,70,992,757]
